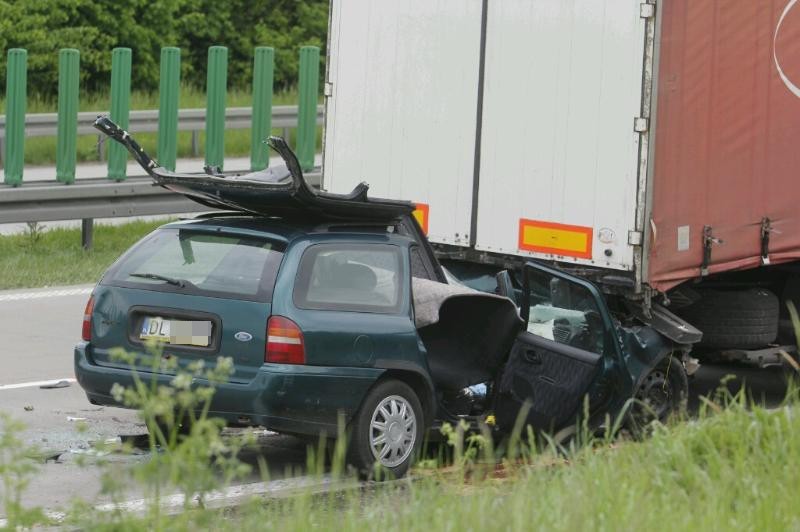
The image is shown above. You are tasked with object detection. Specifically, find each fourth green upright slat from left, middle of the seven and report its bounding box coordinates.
[156,46,181,172]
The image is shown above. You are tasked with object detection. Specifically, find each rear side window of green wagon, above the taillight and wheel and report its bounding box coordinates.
[293,244,404,314]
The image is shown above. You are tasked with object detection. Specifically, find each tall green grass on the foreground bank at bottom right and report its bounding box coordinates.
[244,400,800,531]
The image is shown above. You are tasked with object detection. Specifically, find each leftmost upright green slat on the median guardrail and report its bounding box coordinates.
[4,48,28,187]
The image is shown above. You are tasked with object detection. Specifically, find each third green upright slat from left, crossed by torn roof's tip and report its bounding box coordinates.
[108,48,131,181]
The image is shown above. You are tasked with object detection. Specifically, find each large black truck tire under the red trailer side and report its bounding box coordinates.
[679,288,780,349]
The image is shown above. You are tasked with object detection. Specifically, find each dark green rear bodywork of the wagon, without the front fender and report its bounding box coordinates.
[75,219,433,434]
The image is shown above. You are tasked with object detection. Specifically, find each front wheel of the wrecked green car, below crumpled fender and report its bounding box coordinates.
[632,356,689,428]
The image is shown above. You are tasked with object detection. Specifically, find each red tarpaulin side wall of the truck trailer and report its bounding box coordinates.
[647,0,800,290]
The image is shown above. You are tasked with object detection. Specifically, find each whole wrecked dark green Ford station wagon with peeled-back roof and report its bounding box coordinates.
[75,118,691,476]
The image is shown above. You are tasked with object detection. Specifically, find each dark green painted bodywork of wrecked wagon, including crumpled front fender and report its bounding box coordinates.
[75,216,688,440]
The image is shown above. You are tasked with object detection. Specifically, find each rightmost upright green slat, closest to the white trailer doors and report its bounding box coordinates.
[296,46,319,170]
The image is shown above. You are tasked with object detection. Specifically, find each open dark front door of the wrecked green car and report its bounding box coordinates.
[496,262,617,431]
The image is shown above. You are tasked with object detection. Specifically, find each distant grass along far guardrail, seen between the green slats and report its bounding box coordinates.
[0,86,321,165]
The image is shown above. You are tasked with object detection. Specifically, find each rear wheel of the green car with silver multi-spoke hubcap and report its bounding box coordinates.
[347,379,425,479]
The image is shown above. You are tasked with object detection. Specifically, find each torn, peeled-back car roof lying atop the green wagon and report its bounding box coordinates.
[94,116,414,222]
